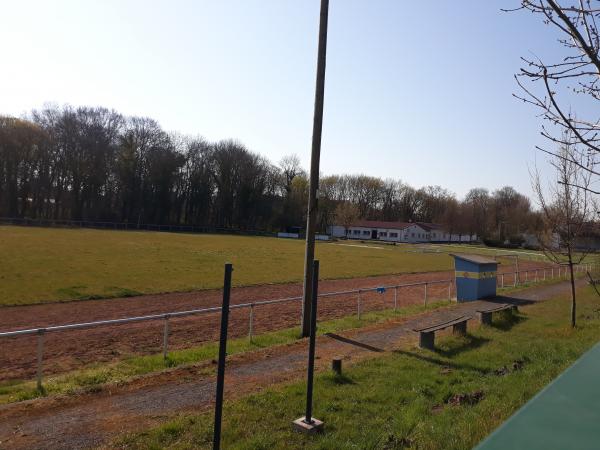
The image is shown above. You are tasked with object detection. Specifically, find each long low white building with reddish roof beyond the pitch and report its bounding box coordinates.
[328,220,477,243]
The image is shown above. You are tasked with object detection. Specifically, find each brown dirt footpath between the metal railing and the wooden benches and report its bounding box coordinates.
[0,280,584,449]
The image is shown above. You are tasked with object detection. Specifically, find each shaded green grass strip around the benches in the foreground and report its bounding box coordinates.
[115,288,600,450]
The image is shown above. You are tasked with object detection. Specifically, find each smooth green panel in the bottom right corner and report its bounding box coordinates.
[476,344,600,450]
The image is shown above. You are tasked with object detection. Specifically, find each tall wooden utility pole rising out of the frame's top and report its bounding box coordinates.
[302,0,329,337]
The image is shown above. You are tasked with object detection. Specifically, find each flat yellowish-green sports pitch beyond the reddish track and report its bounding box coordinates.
[0,226,452,305]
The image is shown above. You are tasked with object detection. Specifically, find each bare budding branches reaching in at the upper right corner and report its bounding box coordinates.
[512,0,600,186]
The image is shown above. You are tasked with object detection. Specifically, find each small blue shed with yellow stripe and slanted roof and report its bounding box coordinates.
[450,255,498,302]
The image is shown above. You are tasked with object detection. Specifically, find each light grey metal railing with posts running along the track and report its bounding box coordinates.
[0,266,587,390]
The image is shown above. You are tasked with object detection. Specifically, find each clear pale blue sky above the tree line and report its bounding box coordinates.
[0,0,557,196]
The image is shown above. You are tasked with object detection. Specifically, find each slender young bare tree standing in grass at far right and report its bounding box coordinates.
[532,136,593,327]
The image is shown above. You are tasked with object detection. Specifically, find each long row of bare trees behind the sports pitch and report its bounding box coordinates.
[0,105,537,239]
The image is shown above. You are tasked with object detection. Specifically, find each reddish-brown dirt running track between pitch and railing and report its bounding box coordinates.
[0,261,543,381]
